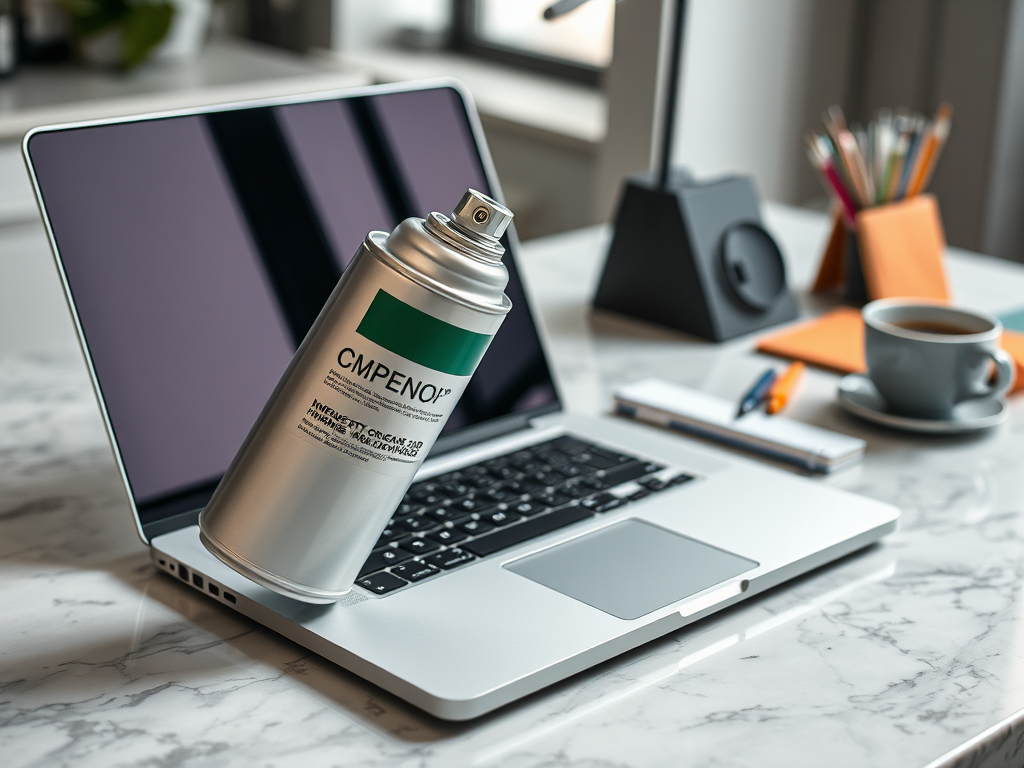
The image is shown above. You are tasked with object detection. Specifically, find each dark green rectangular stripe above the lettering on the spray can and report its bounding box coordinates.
[355,289,492,376]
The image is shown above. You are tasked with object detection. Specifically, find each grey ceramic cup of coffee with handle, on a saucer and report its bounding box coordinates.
[863,299,1014,420]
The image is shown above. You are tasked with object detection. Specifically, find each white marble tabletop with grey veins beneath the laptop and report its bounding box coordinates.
[0,209,1024,768]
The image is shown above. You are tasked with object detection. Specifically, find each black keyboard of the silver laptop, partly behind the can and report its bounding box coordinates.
[356,436,693,595]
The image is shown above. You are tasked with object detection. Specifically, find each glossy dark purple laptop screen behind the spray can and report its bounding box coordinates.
[29,82,557,525]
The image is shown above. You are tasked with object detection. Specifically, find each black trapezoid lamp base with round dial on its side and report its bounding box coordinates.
[594,170,797,341]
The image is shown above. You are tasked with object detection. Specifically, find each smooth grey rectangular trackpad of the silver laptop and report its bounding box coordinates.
[505,519,758,620]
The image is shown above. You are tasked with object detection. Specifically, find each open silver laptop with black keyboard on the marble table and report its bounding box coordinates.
[24,81,899,720]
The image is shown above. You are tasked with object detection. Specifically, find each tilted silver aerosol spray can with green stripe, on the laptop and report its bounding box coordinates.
[199,189,512,603]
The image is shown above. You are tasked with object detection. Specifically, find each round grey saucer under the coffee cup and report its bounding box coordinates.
[839,374,1010,434]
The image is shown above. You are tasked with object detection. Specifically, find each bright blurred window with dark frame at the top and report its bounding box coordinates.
[453,0,614,85]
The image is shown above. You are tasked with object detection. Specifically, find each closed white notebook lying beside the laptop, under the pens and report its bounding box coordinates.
[615,379,866,472]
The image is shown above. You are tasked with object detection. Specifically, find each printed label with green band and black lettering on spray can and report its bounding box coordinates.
[296,290,492,477]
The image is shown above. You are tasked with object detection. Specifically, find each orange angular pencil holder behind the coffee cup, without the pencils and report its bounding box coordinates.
[811,195,949,305]
